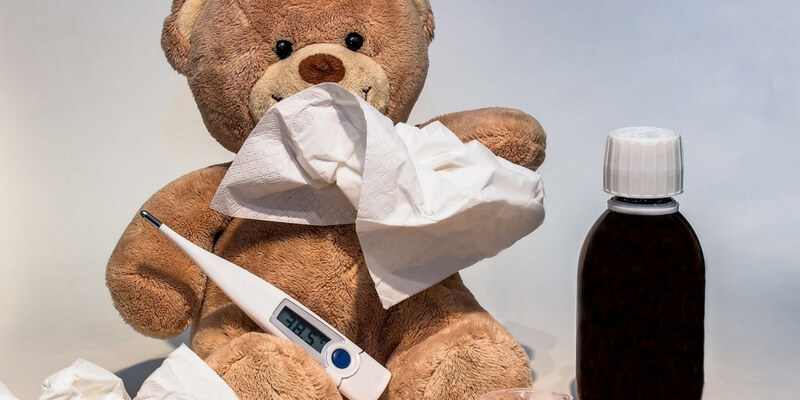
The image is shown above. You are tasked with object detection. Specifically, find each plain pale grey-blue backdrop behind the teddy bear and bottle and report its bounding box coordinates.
[0,0,800,400]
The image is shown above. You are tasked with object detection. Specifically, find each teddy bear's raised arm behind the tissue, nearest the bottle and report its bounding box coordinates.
[422,107,547,170]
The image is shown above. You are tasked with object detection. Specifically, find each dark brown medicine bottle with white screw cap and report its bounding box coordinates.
[577,128,705,400]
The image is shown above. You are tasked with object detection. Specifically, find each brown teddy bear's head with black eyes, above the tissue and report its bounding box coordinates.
[162,0,434,152]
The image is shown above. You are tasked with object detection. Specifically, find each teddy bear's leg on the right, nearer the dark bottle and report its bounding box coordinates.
[382,311,533,400]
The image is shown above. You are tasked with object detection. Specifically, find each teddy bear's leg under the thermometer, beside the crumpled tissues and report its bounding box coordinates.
[206,332,342,400]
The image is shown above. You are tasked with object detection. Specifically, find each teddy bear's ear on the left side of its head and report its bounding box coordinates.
[161,0,206,74]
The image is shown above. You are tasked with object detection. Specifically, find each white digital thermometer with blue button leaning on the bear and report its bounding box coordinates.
[141,211,392,400]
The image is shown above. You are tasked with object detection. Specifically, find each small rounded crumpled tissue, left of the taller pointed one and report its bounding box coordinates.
[39,359,131,400]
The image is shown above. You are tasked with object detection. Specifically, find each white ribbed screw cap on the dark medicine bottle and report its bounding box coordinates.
[603,127,683,199]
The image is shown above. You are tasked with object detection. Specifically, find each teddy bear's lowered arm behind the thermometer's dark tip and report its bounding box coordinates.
[106,166,230,338]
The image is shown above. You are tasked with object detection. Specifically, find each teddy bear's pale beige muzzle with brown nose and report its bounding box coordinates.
[249,43,389,122]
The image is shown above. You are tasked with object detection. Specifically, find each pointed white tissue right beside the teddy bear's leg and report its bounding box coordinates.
[134,344,238,400]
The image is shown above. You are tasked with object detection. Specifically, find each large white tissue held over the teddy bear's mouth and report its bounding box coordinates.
[211,83,544,308]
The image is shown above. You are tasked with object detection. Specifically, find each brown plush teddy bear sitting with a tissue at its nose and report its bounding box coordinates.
[107,0,545,400]
